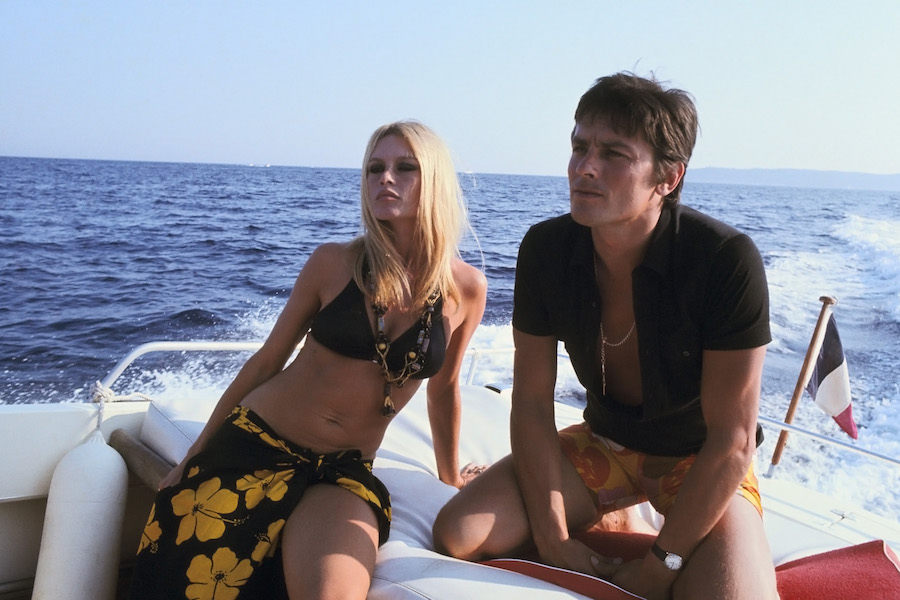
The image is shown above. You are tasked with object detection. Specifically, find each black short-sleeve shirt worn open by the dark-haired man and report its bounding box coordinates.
[513,205,771,456]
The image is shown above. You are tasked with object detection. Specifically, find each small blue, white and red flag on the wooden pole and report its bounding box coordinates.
[806,315,858,440]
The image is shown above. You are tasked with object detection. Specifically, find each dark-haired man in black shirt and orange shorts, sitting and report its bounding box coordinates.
[434,73,777,600]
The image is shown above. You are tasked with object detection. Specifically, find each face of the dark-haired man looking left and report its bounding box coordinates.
[569,119,662,227]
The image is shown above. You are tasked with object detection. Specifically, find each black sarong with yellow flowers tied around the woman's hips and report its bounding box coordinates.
[129,406,391,600]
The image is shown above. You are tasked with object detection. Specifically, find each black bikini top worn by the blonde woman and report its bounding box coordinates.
[309,278,447,379]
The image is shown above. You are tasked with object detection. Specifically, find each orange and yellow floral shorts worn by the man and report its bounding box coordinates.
[559,423,762,515]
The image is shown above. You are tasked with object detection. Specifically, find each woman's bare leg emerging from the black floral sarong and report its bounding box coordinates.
[281,484,378,600]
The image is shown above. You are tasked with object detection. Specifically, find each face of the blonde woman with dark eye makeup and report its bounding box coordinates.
[366,135,422,222]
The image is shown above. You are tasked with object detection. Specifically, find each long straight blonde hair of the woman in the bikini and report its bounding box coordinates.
[353,121,468,307]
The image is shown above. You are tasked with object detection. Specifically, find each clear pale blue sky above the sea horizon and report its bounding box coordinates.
[0,0,900,175]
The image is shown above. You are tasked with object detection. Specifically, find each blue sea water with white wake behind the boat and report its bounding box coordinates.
[0,157,900,518]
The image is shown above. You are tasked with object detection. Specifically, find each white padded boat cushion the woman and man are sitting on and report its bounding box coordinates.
[141,386,616,600]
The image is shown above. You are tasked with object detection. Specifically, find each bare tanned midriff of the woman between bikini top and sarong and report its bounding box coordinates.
[241,336,420,458]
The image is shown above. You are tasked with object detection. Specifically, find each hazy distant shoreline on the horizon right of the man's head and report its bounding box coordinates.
[685,167,900,192]
